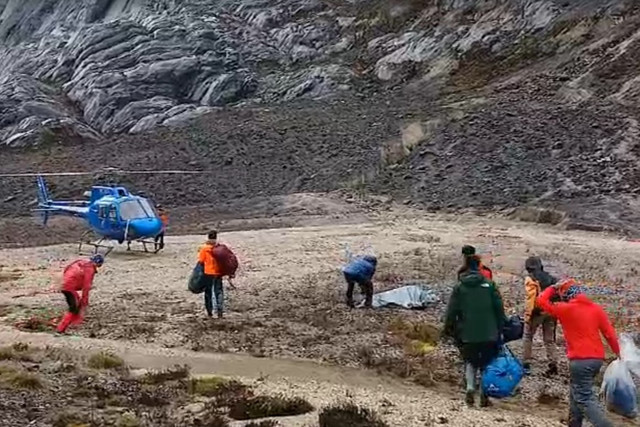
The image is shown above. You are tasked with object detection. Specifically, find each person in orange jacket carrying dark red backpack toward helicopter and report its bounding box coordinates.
[198,230,238,319]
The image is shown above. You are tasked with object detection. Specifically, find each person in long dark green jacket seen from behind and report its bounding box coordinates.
[444,258,505,407]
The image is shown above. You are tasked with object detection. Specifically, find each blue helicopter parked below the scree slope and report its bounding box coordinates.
[2,168,202,253]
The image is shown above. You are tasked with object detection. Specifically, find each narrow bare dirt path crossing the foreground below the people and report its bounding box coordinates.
[0,327,561,427]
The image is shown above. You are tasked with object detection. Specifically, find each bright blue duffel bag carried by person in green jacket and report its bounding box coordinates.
[482,345,524,399]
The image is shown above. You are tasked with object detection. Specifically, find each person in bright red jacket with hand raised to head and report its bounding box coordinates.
[536,279,620,427]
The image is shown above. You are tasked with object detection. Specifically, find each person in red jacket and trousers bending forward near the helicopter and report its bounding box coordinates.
[56,254,104,334]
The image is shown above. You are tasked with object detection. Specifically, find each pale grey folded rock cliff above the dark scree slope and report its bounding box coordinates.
[0,0,637,146]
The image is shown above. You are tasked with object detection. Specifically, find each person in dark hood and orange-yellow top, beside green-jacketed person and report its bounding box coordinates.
[522,256,558,376]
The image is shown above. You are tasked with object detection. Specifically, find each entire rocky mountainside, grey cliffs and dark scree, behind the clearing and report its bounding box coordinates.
[0,0,640,236]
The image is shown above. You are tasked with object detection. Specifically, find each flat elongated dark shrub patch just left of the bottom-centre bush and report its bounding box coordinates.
[229,396,314,420]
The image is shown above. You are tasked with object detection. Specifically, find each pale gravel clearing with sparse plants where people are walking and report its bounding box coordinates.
[0,208,640,426]
